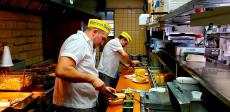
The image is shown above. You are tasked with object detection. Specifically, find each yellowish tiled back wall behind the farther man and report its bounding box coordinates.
[114,9,146,55]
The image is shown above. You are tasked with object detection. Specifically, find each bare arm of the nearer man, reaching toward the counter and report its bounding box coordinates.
[55,56,115,92]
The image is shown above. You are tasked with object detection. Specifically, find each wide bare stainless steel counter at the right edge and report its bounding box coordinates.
[176,57,230,107]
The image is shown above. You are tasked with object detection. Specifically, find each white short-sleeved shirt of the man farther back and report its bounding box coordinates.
[98,38,123,78]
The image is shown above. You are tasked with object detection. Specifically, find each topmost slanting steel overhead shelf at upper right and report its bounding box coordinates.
[160,0,230,25]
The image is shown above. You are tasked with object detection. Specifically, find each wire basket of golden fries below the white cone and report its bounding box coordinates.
[0,72,32,91]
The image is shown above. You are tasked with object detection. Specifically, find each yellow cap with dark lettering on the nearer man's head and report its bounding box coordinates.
[88,19,112,33]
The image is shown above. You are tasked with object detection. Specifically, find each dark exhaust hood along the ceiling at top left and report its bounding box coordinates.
[0,0,99,18]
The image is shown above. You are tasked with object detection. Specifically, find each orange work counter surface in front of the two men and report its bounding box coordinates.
[107,70,151,112]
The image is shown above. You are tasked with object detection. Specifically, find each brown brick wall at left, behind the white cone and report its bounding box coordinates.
[0,11,43,65]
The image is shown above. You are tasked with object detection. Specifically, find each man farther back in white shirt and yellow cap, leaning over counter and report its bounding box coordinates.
[98,32,134,87]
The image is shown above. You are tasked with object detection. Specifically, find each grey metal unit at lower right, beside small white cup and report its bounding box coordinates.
[167,80,208,112]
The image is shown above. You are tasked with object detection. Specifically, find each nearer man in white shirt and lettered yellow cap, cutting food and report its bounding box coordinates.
[53,19,115,112]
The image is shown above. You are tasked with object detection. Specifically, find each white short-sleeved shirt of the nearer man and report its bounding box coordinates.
[53,31,98,109]
